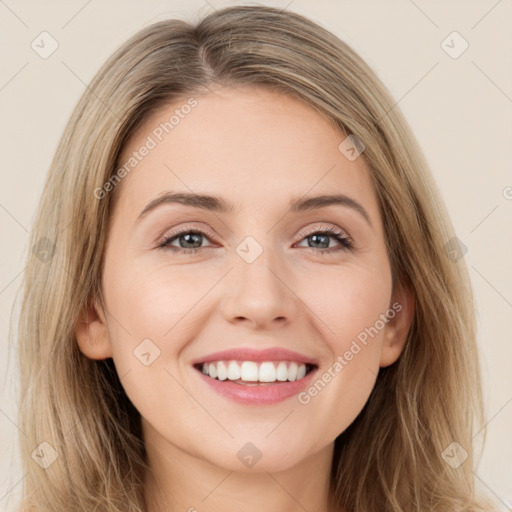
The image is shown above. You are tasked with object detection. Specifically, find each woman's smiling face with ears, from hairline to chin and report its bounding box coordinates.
[77,88,408,471]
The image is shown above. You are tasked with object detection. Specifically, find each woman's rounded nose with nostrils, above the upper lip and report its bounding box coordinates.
[222,242,300,329]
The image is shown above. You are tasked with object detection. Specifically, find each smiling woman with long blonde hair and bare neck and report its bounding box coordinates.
[13,6,500,512]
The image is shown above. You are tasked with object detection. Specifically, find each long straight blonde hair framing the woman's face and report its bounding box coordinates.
[12,6,498,512]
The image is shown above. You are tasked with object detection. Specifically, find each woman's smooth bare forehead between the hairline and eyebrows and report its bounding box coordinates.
[116,83,376,218]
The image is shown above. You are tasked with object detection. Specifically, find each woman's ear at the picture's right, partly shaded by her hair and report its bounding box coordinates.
[380,285,415,368]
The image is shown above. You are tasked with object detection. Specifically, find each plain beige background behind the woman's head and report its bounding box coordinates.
[0,0,512,510]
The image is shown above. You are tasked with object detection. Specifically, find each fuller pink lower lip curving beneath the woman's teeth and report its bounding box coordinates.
[194,368,317,405]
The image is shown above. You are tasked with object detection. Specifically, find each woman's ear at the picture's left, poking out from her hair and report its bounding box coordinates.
[74,299,112,359]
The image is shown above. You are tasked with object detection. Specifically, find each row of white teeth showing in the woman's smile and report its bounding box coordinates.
[197,361,306,382]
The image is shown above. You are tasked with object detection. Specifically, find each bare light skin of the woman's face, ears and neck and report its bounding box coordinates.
[75,88,414,512]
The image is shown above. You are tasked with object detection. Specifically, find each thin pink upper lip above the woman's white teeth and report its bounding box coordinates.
[192,347,318,366]
